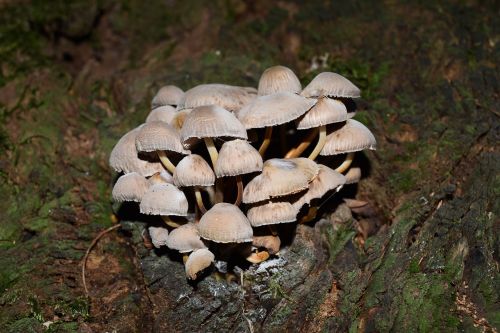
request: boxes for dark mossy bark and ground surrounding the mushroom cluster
[0,0,500,332]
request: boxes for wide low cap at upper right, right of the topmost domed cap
[300,72,361,98]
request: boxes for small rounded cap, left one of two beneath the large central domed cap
[174,154,215,187]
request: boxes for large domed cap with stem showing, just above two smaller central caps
[181,105,247,144]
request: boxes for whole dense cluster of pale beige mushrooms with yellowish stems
[109,66,376,280]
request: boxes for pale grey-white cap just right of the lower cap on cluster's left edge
[139,183,189,216]
